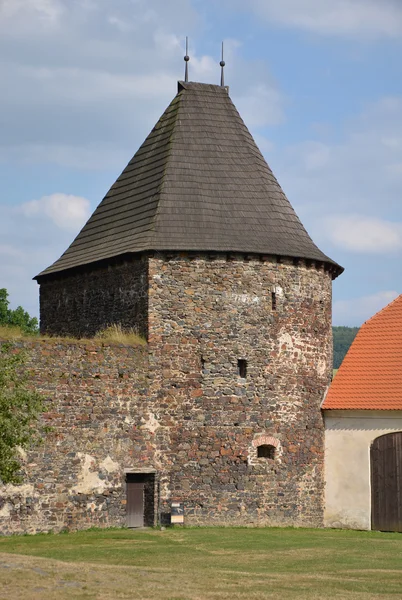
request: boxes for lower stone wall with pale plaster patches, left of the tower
[0,341,155,534]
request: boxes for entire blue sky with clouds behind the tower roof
[0,0,402,325]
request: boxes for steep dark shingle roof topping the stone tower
[37,82,343,278]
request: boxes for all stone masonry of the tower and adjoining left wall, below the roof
[5,253,332,533]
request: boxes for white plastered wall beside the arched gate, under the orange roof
[324,410,402,529]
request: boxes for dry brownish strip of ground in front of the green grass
[0,553,395,600]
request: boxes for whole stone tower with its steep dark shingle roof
[36,82,342,526]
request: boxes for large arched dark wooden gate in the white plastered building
[371,432,402,532]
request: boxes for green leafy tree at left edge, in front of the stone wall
[0,344,48,483]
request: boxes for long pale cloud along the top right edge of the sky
[243,0,402,37]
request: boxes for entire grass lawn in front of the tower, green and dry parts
[0,528,402,600]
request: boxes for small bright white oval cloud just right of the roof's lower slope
[322,215,402,254]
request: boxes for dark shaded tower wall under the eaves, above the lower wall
[40,257,148,338]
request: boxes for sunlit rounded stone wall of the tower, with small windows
[148,254,332,526]
